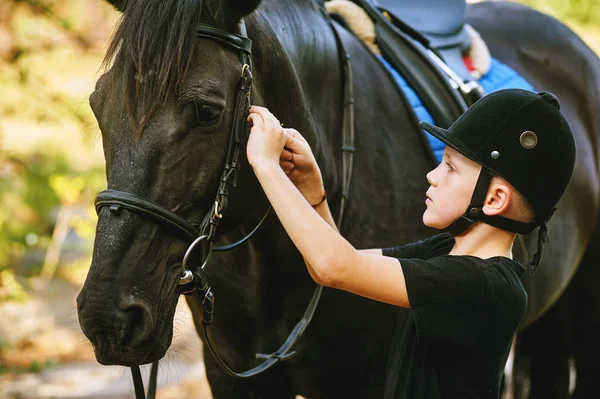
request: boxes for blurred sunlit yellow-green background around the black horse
[0,0,600,398]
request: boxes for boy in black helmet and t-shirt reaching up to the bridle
[247,89,575,399]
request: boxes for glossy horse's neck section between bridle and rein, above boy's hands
[249,0,342,181]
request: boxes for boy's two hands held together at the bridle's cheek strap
[246,106,324,204]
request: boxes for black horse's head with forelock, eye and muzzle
[77,0,260,365]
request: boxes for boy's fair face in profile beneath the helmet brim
[423,147,481,229]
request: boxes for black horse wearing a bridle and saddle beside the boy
[78,0,600,398]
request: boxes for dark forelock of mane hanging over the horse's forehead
[104,0,231,135]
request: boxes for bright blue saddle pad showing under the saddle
[378,56,534,162]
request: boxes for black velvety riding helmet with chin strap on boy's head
[420,89,575,271]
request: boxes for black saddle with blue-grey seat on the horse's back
[353,0,483,127]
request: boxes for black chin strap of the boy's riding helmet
[445,167,555,273]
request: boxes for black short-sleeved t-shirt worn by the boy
[383,234,527,399]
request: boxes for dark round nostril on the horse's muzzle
[117,297,154,346]
